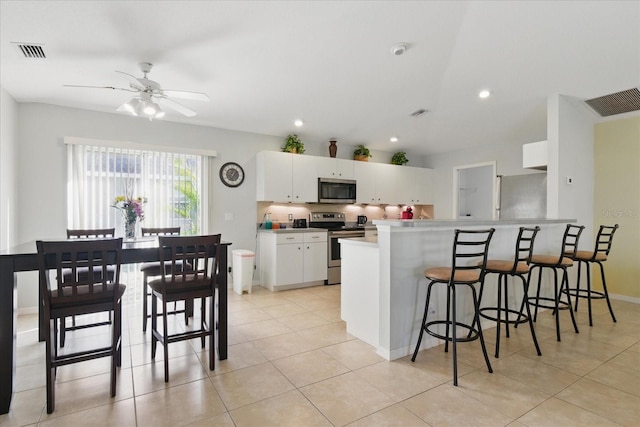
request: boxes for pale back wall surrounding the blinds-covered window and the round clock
[15,104,282,307]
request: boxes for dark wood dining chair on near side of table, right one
[149,234,224,382]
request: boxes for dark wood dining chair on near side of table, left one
[36,239,126,414]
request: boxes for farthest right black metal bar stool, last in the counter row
[564,224,618,326]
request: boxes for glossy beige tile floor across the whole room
[0,286,640,427]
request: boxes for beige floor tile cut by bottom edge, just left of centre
[230,390,331,427]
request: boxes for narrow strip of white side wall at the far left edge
[0,87,18,250]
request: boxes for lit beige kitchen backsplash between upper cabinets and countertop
[256,202,433,225]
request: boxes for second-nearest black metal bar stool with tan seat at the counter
[479,226,542,357]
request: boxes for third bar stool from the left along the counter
[520,224,584,341]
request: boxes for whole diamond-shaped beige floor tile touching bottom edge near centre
[300,373,394,425]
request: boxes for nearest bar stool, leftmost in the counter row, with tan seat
[411,228,495,386]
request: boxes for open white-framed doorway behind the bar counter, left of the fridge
[453,161,497,219]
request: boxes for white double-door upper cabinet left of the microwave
[256,151,318,203]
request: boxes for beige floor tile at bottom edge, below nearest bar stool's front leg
[401,384,512,427]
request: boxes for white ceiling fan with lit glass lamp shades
[64,62,209,120]
